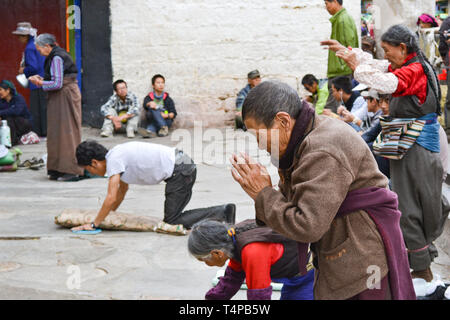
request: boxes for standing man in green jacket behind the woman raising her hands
[325,0,359,112]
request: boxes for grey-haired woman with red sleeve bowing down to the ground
[188,220,314,300]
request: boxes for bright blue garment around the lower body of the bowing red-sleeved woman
[272,269,314,300]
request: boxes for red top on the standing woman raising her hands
[392,62,428,103]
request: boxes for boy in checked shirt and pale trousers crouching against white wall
[100,80,139,138]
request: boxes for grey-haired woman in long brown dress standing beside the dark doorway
[29,34,83,181]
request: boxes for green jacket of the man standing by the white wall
[328,8,359,78]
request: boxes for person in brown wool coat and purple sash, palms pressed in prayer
[231,81,416,300]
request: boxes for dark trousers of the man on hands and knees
[164,150,232,229]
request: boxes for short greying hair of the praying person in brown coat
[242,80,302,128]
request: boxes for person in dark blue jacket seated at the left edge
[0,80,33,146]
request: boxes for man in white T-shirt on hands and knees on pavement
[73,141,236,231]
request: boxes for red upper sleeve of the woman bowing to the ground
[241,242,284,289]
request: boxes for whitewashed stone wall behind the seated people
[110,0,361,127]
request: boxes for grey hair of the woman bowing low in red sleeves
[188,220,235,259]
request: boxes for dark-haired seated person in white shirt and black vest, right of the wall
[331,77,368,127]
